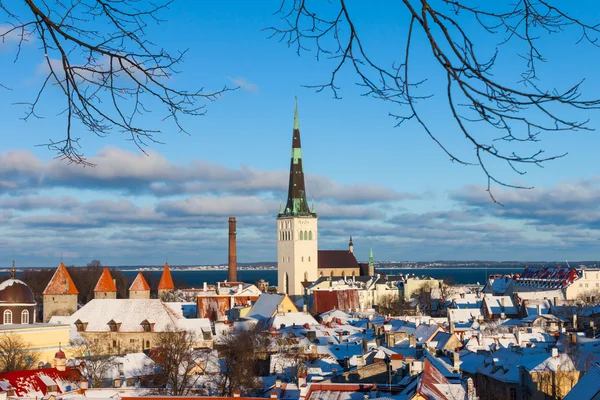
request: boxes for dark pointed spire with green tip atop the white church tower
[279,98,316,217]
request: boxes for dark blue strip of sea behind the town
[118,268,523,288]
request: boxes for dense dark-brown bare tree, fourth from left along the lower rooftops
[215,329,267,397]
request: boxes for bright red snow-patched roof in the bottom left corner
[0,368,81,397]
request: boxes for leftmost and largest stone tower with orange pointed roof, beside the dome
[42,262,79,322]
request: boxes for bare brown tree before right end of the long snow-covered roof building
[153,327,209,396]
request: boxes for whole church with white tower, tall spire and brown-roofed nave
[277,102,366,300]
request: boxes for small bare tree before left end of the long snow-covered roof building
[70,338,116,387]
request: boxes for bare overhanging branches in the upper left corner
[0,0,229,165]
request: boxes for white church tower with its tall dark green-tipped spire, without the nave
[277,101,319,300]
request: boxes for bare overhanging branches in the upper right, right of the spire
[269,0,600,202]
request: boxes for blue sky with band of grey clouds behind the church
[0,0,600,267]
